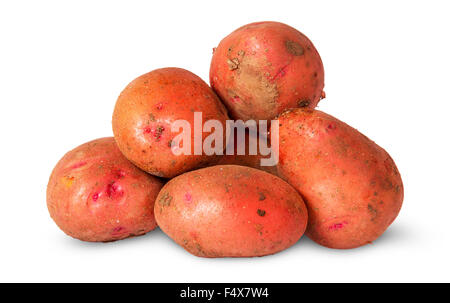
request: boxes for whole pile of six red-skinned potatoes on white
[47,22,403,257]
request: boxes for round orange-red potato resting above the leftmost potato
[112,68,228,178]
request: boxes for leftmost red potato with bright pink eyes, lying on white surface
[47,137,163,242]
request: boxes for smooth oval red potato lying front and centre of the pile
[155,165,308,258]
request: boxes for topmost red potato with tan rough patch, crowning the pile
[210,22,325,120]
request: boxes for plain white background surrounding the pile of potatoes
[0,0,450,282]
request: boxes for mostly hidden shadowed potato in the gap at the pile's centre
[217,132,278,176]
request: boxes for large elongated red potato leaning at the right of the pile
[278,109,403,249]
